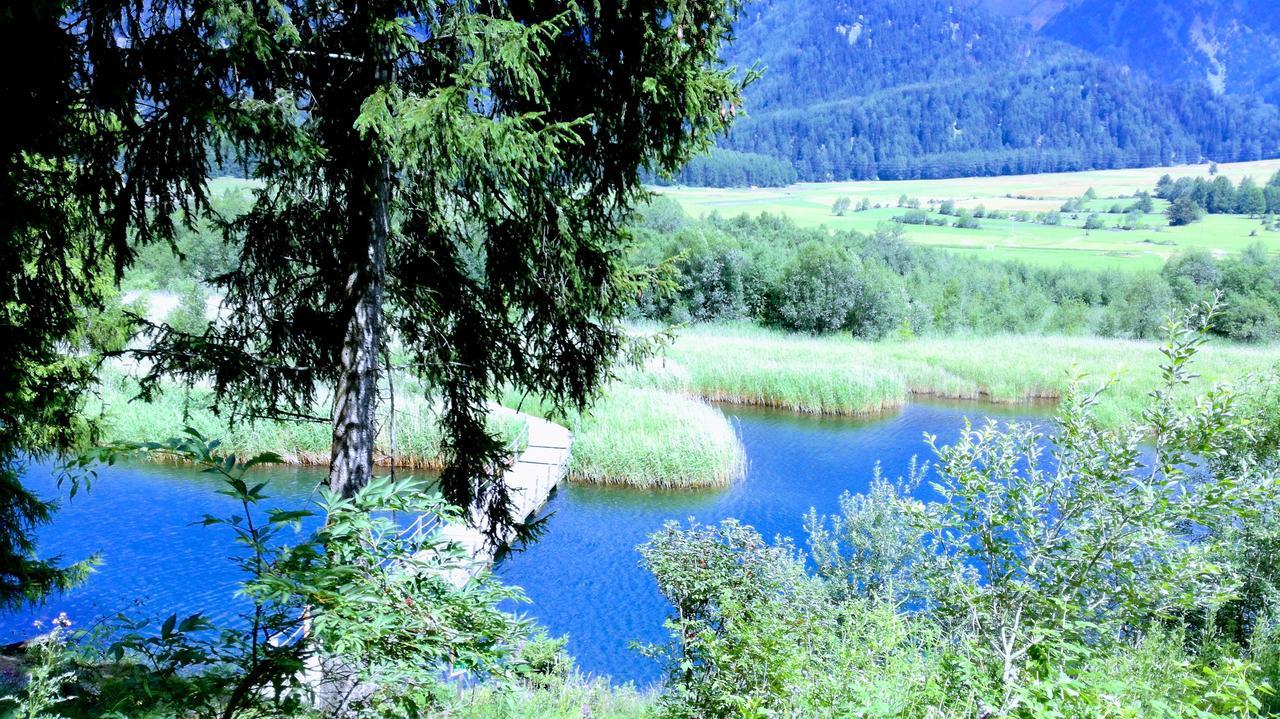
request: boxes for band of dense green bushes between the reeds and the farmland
[634,198,1280,342]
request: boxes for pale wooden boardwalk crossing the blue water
[442,415,573,585]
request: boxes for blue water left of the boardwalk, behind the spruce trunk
[0,461,427,642]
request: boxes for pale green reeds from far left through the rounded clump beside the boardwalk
[97,363,745,489]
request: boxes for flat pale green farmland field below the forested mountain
[659,160,1280,270]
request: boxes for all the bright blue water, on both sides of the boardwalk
[0,403,1044,683]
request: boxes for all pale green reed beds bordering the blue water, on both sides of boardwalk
[102,325,1280,490]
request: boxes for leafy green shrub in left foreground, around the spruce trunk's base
[55,431,526,719]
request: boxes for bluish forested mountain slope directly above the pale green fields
[682,0,1280,186]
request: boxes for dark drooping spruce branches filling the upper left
[0,0,744,598]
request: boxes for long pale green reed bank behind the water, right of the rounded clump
[662,326,1280,423]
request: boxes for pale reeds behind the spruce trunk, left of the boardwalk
[90,370,524,470]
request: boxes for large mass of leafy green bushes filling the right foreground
[640,306,1280,719]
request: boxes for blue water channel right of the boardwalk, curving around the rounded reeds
[498,402,1048,684]
